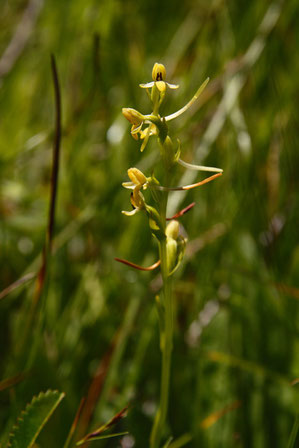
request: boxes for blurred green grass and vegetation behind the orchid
[0,0,299,448]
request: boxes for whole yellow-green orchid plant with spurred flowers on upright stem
[116,63,222,448]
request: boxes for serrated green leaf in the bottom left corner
[8,390,65,448]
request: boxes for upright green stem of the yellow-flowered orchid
[150,189,173,448]
